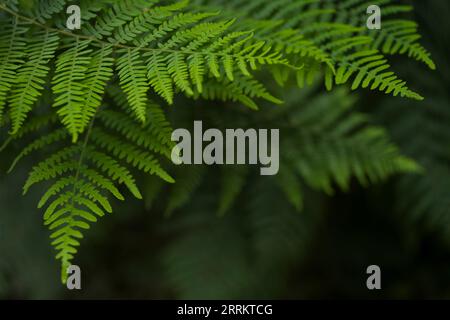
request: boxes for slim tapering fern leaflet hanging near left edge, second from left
[9,31,59,134]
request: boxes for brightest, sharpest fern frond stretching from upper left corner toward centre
[0,0,288,142]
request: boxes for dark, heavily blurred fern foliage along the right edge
[376,1,450,245]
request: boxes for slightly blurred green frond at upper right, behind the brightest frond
[194,0,435,100]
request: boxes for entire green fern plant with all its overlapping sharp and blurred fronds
[0,0,434,281]
